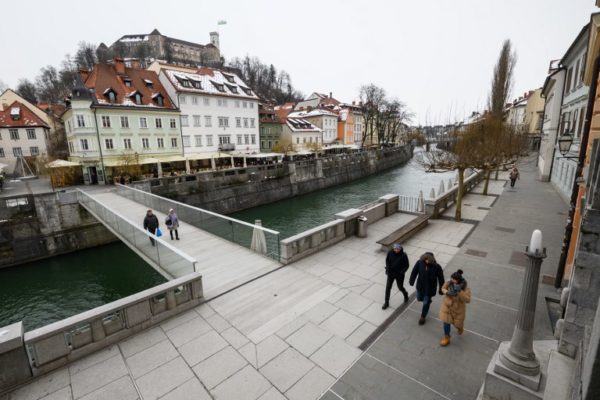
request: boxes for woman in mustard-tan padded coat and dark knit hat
[440,269,471,346]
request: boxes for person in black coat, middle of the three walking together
[409,252,444,325]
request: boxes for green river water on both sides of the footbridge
[0,155,454,330]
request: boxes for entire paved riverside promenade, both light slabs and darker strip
[0,158,567,400]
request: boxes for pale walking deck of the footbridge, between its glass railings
[89,192,281,299]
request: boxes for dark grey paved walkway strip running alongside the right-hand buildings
[321,158,567,400]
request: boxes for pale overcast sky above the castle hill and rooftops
[0,0,598,123]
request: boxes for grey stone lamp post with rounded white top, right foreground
[494,229,546,390]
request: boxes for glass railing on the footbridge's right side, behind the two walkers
[115,184,280,261]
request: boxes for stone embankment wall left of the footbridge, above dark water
[0,193,117,268]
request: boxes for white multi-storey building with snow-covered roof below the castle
[159,67,260,156]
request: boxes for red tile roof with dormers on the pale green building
[82,61,176,109]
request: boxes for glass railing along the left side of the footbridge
[76,189,197,279]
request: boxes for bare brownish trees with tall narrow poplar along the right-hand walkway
[420,40,527,221]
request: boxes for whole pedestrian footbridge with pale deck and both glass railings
[77,185,281,299]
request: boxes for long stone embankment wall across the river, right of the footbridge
[134,145,413,214]
